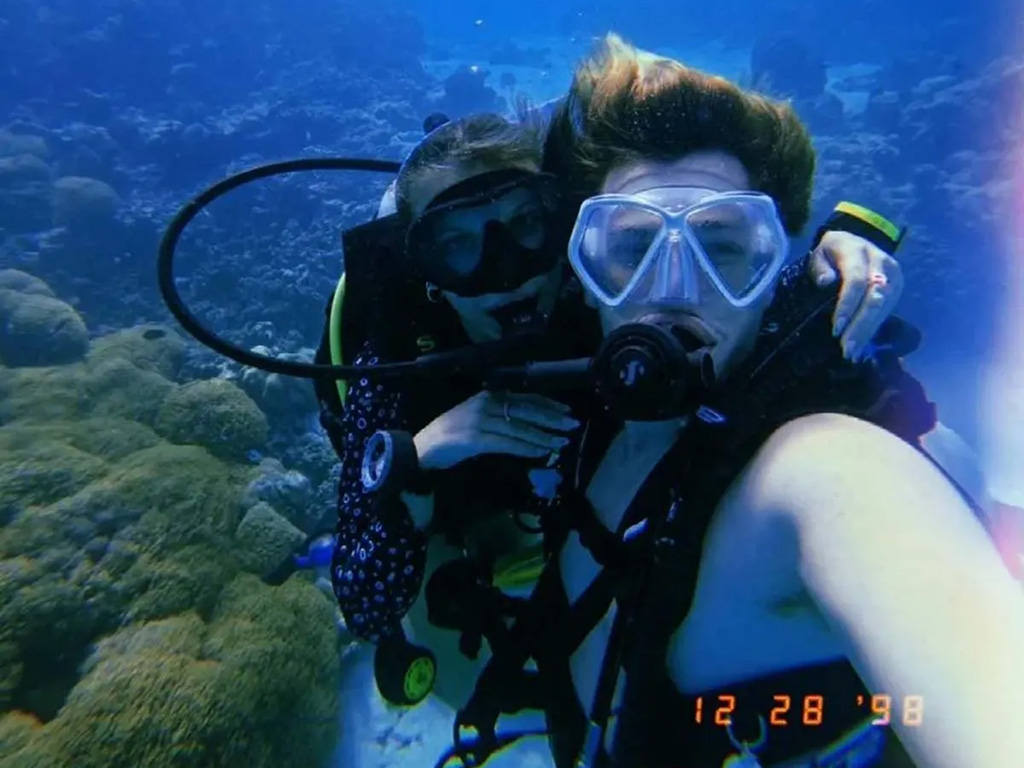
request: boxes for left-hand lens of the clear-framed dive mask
[578,205,663,300]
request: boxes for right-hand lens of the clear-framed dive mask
[686,200,786,299]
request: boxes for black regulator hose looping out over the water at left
[157,158,476,380]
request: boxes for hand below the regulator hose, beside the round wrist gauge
[414,390,580,470]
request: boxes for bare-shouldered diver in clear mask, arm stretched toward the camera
[428,37,1024,768]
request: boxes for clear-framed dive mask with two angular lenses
[568,186,790,308]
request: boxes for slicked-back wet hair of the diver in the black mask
[395,112,544,224]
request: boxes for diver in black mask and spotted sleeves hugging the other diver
[316,107,902,706]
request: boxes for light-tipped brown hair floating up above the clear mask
[545,35,815,234]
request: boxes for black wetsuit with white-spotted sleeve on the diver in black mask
[315,211,600,642]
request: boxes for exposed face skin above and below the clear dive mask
[590,151,772,375]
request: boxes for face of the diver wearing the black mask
[408,163,562,342]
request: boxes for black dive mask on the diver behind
[406,169,558,297]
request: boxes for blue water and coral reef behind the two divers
[0,0,1024,768]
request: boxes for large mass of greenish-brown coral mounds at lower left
[0,325,338,768]
